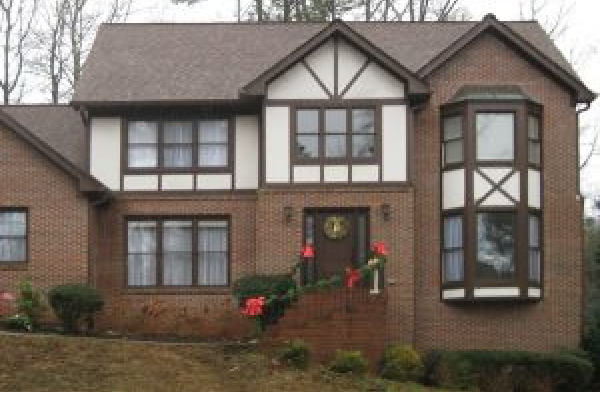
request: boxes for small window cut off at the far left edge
[0,210,27,263]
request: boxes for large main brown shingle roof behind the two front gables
[73,22,573,103]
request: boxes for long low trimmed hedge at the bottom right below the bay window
[425,351,594,391]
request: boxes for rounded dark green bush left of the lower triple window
[48,284,104,333]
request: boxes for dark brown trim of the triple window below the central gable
[288,100,383,165]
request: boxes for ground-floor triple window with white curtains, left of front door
[127,218,229,287]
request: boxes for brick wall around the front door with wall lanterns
[256,187,414,342]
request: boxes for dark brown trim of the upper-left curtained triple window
[121,115,235,175]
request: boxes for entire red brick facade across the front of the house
[0,26,582,350]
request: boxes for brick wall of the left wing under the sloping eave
[0,122,88,315]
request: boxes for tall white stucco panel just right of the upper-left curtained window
[235,116,259,189]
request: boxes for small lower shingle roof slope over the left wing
[0,105,87,172]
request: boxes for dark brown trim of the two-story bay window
[440,100,544,303]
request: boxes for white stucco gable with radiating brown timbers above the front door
[267,37,405,100]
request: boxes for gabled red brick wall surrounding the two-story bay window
[414,35,582,350]
